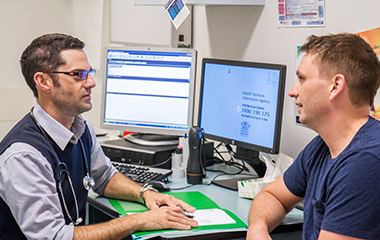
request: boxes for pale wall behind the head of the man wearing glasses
[0,0,104,140]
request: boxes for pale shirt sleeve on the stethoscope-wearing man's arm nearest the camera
[0,143,74,239]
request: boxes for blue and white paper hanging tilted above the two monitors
[165,0,190,29]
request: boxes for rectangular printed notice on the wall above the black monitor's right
[278,0,325,27]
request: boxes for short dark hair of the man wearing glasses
[20,33,85,98]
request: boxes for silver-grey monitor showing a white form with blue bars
[101,46,197,145]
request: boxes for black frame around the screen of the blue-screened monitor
[198,58,286,154]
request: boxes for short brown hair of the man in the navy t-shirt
[300,33,380,106]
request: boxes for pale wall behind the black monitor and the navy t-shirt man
[193,0,380,158]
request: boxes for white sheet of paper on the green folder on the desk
[192,208,236,226]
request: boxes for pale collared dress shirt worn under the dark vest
[0,103,117,240]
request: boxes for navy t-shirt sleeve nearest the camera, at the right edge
[321,153,380,239]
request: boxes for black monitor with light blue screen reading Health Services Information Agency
[198,58,286,177]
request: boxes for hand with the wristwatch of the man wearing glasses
[143,191,195,212]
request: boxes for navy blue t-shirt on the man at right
[284,117,380,239]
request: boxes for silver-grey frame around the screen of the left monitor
[100,46,197,136]
